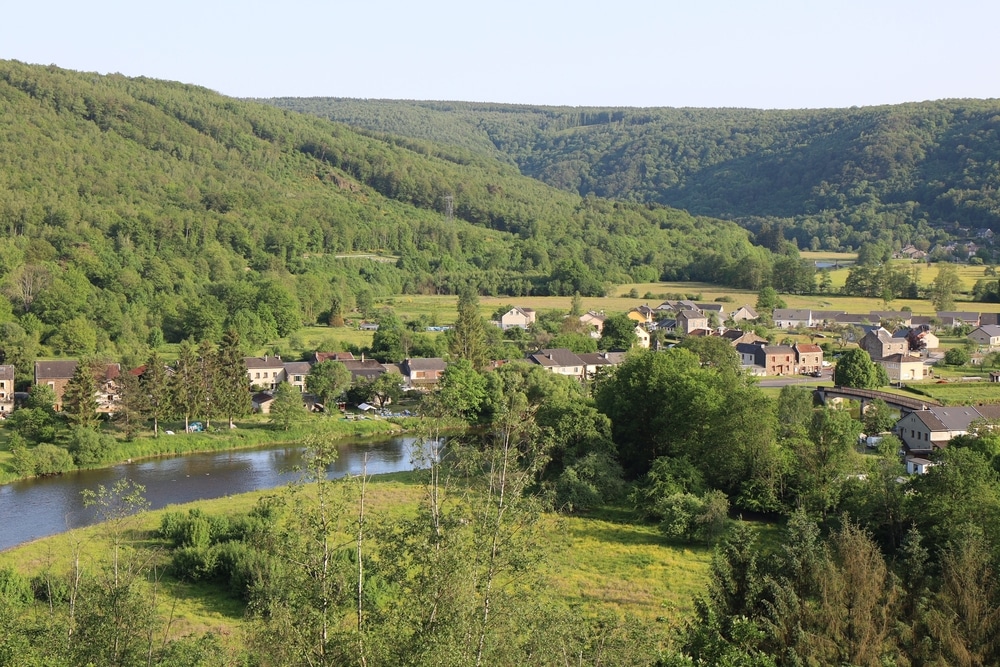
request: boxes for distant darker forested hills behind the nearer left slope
[268,98,1000,250]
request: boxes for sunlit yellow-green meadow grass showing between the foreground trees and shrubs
[0,472,720,637]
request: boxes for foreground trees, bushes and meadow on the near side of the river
[0,352,1000,665]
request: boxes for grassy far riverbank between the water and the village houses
[0,416,430,485]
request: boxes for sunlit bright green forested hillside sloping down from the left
[0,61,761,373]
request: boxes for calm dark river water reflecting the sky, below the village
[0,437,426,551]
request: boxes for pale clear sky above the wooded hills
[0,0,1000,109]
